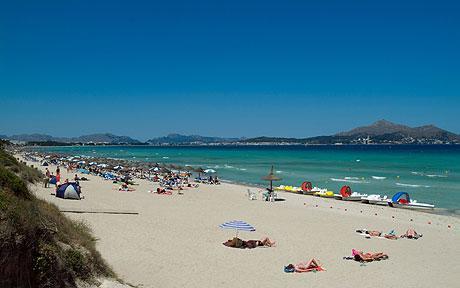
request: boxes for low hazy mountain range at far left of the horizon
[6,133,142,144]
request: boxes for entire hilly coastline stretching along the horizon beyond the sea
[0,120,460,147]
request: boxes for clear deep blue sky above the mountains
[0,0,460,139]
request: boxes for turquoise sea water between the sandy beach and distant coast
[33,146,460,213]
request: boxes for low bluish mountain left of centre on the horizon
[147,134,240,145]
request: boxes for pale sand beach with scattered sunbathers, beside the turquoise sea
[20,158,460,288]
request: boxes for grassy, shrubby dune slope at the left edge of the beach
[0,148,115,288]
